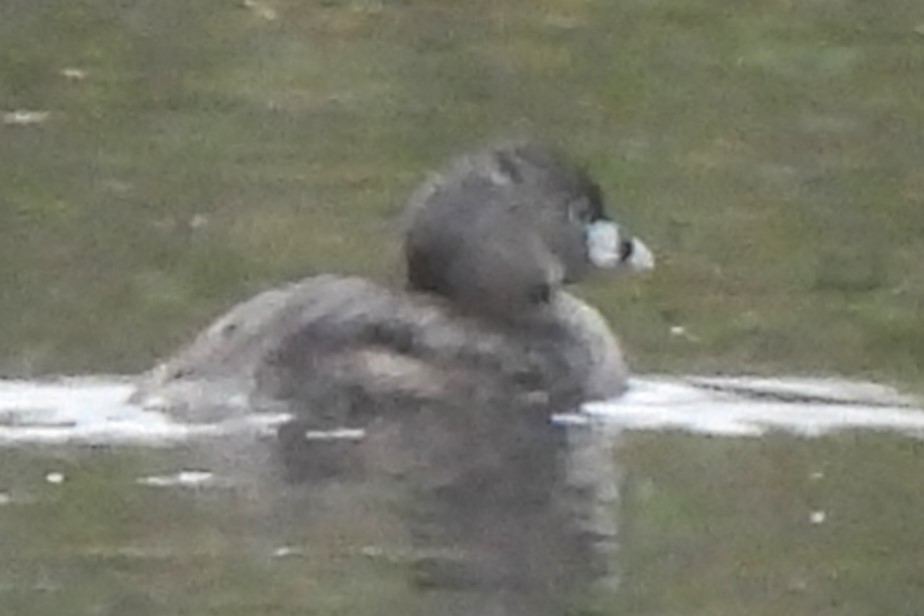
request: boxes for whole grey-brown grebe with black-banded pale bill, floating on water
[135,143,652,438]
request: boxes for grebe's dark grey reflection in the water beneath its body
[281,390,618,616]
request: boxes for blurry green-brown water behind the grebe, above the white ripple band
[0,0,924,386]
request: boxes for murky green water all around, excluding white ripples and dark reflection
[0,0,924,616]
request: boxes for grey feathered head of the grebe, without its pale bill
[405,143,605,314]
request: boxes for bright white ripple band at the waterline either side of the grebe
[0,376,924,446]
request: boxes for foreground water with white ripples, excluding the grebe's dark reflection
[0,377,924,615]
